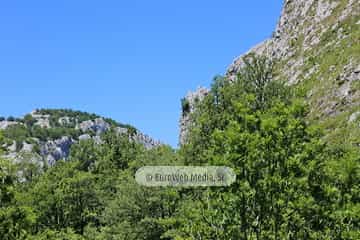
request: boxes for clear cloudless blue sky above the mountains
[0,0,282,146]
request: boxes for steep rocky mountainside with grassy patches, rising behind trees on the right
[179,0,360,145]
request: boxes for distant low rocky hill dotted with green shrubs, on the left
[0,109,161,169]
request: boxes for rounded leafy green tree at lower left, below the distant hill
[24,162,100,233]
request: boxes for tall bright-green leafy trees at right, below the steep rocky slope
[173,55,360,239]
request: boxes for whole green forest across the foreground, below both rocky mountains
[0,56,360,240]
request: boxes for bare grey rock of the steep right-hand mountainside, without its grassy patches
[179,0,360,144]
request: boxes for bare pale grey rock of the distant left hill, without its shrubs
[0,110,161,166]
